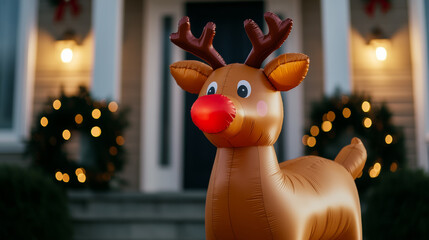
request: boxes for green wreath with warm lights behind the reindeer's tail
[302,94,405,193]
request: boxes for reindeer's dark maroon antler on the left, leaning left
[170,17,226,69]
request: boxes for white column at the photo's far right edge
[408,0,429,171]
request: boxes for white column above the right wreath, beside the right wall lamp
[321,0,351,96]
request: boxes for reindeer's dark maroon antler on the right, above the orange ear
[244,12,292,68]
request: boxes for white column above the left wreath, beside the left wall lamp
[91,0,123,101]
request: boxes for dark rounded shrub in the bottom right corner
[363,170,429,240]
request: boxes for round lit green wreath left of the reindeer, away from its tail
[27,87,127,189]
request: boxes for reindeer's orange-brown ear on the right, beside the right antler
[264,53,310,91]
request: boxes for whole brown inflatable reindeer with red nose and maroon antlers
[170,13,366,240]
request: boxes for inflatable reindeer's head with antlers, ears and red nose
[170,13,309,147]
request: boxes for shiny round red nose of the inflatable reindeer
[191,94,235,133]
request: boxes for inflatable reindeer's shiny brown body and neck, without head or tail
[206,146,362,240]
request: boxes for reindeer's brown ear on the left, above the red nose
[170,60,213,94]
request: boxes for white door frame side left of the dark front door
[140,0,184,192]
